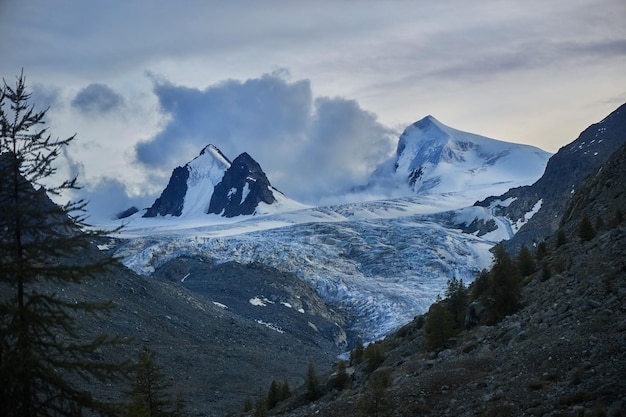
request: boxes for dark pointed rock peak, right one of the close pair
[208,152,276,217]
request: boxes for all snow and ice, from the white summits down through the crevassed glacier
[113,116,550,341]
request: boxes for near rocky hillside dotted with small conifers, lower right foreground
[272,145,626,417]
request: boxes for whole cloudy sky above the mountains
[0,0,626,218]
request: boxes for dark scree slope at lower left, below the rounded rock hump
[0,244,341,416]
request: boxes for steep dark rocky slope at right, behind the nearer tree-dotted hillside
[476,104,626,253]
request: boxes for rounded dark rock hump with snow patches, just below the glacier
[149,257,348,352]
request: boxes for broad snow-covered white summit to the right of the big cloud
[370,116,550,199]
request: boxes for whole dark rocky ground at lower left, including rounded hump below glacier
[0,242,345,416]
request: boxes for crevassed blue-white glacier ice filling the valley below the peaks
[116,195,512,341]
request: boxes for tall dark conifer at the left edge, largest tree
[0,73,127,417]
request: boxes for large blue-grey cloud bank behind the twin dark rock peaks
[136,71,395,202]
